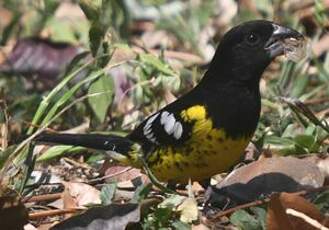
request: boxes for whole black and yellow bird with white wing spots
[37,20,303,183]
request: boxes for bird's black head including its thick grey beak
[208,20,303,84]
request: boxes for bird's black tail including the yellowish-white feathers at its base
[35,133,141,165]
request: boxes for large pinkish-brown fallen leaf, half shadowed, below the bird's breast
[206,157,324,208]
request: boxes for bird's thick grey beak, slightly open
[265,23,304,58]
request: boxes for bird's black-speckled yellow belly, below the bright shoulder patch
[151,130,249,182]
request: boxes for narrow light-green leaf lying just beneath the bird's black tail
[37,145,86,161]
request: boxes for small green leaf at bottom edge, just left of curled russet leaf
[230,209,262,230]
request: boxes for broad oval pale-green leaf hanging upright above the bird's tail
[88,74,114,122]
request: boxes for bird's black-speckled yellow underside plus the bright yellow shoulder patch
[147,105,251,182]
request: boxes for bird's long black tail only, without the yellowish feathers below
[35,133,134,154]
